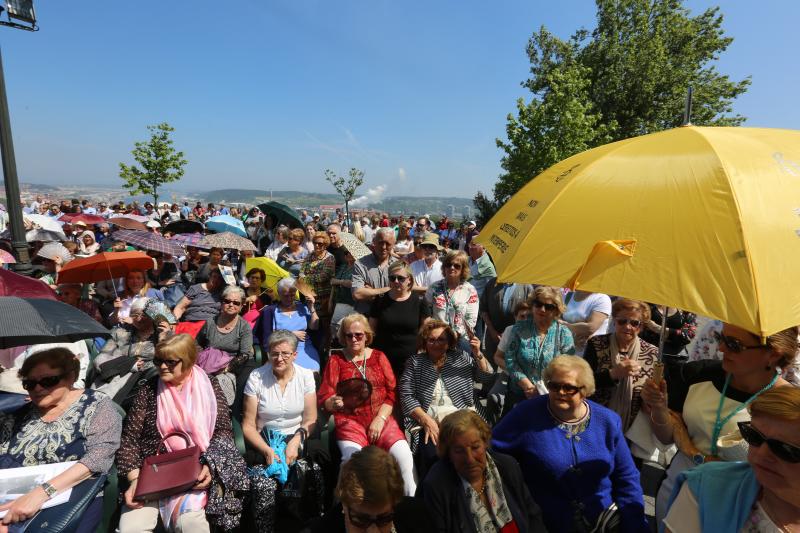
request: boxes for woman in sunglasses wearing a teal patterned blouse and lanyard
[503,287,575,413]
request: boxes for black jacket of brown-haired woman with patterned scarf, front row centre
[417,451,547,533]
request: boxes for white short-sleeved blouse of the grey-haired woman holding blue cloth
[244,363,316,435]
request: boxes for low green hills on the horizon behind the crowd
[200,189,475,217]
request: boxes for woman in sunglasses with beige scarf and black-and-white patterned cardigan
[583,298,658,432]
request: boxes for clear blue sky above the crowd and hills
[0,0,800,197]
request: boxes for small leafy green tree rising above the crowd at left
[119,122,187,208]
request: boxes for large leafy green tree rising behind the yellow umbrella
[475,0,750,222]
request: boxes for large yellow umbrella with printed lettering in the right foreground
[477,126,800,336]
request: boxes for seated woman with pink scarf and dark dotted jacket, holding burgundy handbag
[117,335,233,533]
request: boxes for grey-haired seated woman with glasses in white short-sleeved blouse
[242,329,317,465]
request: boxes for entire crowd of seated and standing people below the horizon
[0,197,800,533]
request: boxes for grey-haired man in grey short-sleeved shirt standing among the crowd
[353,228,395,314]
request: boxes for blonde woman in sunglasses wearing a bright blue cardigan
[492,355,648,532]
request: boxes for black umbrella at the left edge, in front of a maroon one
[0,296,111,348]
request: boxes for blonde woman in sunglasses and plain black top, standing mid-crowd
[369,261,428,377]
